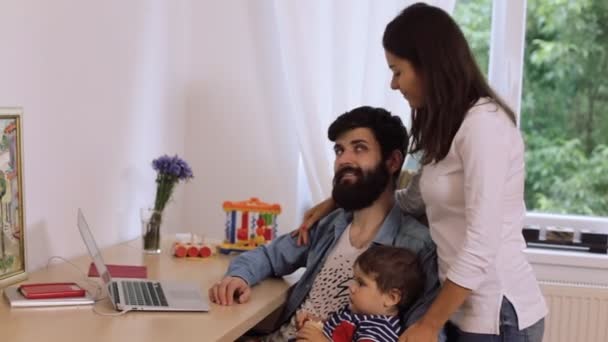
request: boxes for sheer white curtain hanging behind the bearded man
[256,0,455,203]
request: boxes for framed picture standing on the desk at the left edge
[0,107,27,288]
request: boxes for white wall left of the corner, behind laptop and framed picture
[0,0,187,269]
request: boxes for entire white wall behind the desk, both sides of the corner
[0,0,306,270]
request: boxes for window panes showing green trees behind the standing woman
[454,0,608,231]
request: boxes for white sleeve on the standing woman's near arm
[446,111,512,291]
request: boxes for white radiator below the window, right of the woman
[539,275,608,342]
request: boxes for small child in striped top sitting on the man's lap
[297,245,424,341]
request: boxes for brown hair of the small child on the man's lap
[355,245,425,312]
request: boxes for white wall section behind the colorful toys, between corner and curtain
[184,0,302,238]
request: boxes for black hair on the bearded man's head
[327,106,409,181]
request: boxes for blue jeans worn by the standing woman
[446,297,545,342]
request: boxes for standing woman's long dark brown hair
[382,3,516,165]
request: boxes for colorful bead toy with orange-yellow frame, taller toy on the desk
[218,197,281,254]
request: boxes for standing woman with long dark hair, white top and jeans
[300,4,547,342]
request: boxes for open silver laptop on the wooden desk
[78,209,209,312]
